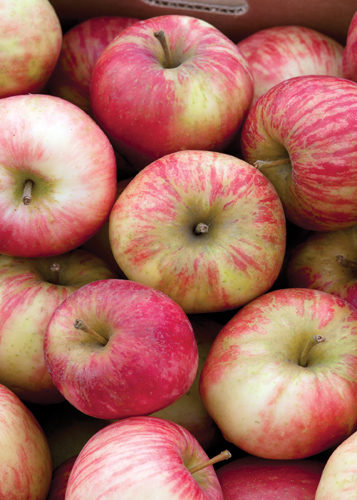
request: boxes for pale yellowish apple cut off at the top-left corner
[0,0,62,97]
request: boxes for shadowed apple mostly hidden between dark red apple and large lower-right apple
[152,316,222,450]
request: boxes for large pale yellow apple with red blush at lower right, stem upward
[200,288,357,460]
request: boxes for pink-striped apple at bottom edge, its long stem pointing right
[66,417,223,500]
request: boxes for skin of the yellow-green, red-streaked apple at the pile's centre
[109,151,286,313]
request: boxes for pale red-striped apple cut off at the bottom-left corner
[0,384,52,500]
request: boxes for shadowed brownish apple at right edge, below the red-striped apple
[286,226,357,307]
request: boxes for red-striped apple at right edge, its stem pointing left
[241,75,357,231]
